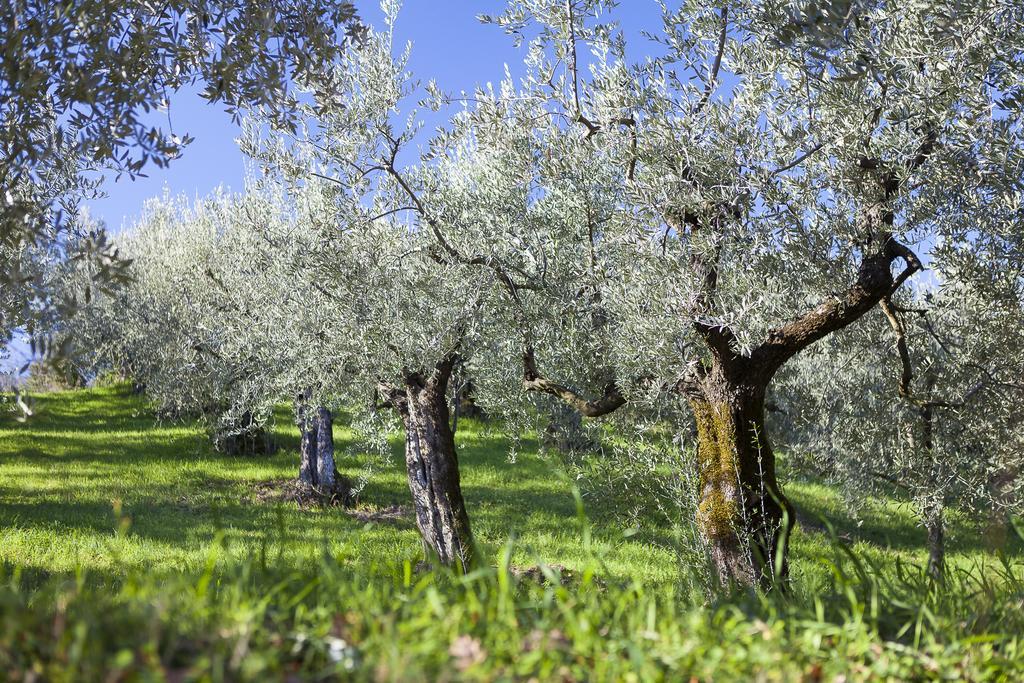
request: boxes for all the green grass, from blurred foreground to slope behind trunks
[0,388,1024,680]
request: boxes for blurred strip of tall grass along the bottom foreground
[0,558,1024,681]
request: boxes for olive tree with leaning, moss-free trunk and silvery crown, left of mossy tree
[245,163,493,570]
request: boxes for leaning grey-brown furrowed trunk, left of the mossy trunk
[383,359,475,571]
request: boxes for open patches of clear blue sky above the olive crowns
[88,0,659,230]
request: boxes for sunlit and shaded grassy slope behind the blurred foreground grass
[0,388,1021,583]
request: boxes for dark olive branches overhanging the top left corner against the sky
[0,0,359,360]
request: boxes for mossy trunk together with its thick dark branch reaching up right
[677,233,922,589]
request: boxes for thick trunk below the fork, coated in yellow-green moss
[688,366,795,589]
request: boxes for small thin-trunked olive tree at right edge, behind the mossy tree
[777,284,1024,578]
